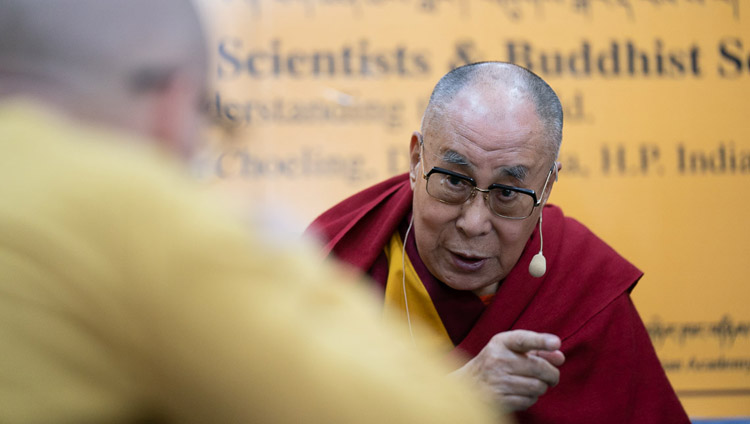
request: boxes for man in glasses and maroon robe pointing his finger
[310,62,689,424]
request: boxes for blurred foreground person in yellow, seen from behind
[0,0,506,423]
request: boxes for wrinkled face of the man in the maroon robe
[411,90,557,294]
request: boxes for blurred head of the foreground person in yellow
[0,0,207,156]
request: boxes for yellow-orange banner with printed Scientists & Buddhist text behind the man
[195,0,750,417]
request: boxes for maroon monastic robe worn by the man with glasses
[310,174,689,424]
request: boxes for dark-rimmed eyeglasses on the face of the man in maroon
[422,147,555,219]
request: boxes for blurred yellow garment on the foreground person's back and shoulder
[0,101,506,424]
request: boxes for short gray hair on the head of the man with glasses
[421,62,563,159]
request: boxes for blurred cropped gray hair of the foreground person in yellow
[0,0,205,94]
